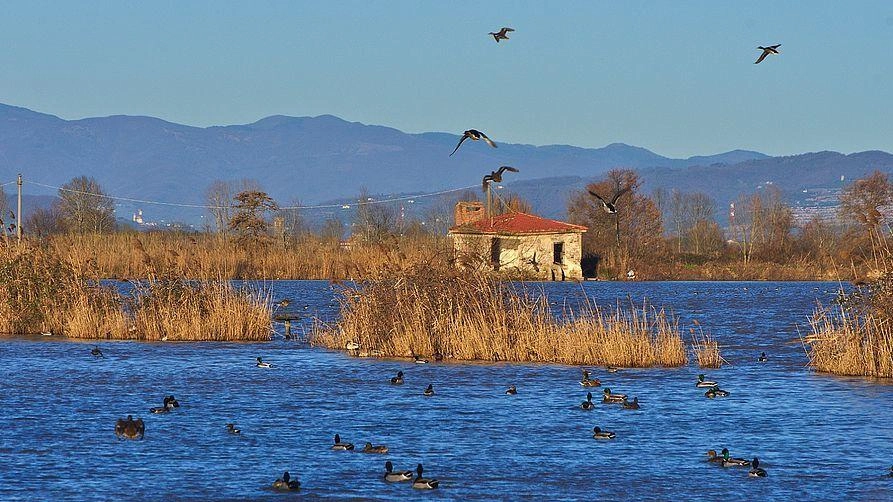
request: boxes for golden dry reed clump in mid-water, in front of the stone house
[310,267,687,367]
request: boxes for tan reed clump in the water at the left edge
[0,242,272,341]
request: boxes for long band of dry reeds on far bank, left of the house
[48,232,452,280]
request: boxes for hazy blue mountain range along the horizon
[0,104,893,223]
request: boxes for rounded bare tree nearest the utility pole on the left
[57,176,115,233]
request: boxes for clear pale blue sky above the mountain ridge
[0,0,893,157]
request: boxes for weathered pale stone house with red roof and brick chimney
[449,202,586,281]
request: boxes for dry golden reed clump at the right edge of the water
[804,308,893,378]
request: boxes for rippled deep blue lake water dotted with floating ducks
[0,281,893,500]
